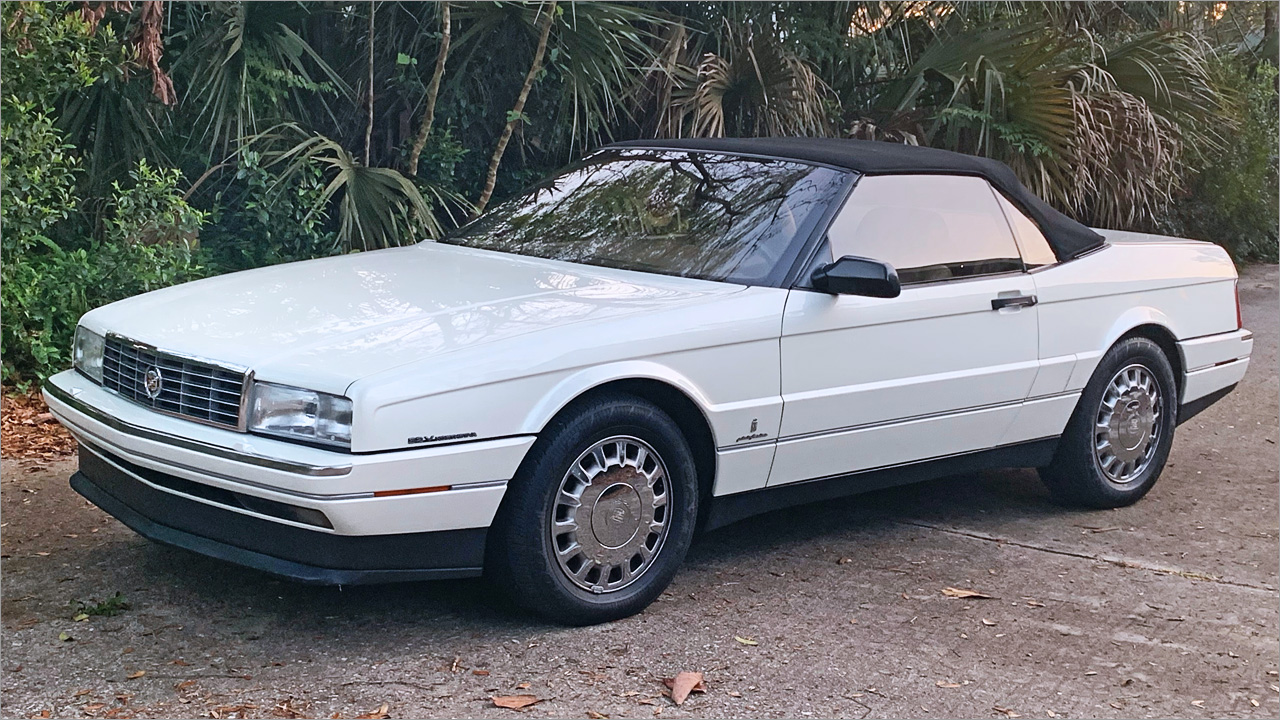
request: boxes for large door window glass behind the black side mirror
[828,176,1023,284]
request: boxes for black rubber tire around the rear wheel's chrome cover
[1039,337,1178,509]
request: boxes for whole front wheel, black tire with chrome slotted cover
[485,395,698,625]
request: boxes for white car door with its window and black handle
[769,176,1038,486]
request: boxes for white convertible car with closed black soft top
[45,138,1252,624]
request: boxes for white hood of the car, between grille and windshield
[82,242,742,393]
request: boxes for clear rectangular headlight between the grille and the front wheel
[248,383,351,448]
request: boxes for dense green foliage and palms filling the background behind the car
[0,0,1280,383]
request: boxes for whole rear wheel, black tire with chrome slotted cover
[1039,337,1178,507]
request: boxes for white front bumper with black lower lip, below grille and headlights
[45,372,534,584]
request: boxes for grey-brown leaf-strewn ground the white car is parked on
[0,266,1280,717]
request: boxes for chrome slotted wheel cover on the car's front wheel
[549,436,671,594]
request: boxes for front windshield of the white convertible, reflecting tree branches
[442,149,847,284]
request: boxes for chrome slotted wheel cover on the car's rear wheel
[1093,364,1161,486]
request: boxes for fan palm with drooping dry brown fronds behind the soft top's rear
[851,16,1221,227]
